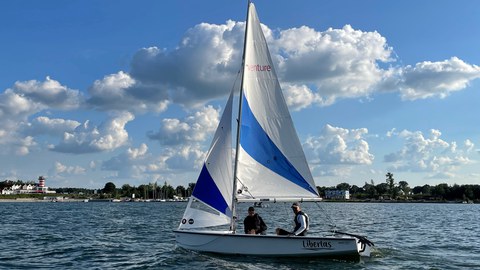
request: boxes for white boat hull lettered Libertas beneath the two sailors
[174,230,370,259]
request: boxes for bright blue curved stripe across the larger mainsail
[240,96,317,194]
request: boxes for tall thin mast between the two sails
[230,0,251,233]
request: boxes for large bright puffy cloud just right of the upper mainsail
[271,25,393,105]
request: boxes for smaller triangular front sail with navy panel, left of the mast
[179,90,234,229]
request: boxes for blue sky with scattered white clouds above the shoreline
[0,0,480,188]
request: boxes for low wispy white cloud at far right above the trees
[384,129,473,175]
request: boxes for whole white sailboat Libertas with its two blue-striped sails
[174,1,373,258]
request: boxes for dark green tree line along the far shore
[0,172,480,202]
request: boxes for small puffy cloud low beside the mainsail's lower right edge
[303,125,374,165]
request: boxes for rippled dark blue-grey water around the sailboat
[0,202,480,270]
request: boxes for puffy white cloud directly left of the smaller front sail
[102,106,220,179]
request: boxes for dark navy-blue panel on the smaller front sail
[192,164,230,215]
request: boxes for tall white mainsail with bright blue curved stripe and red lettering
[237,4,318,198]
